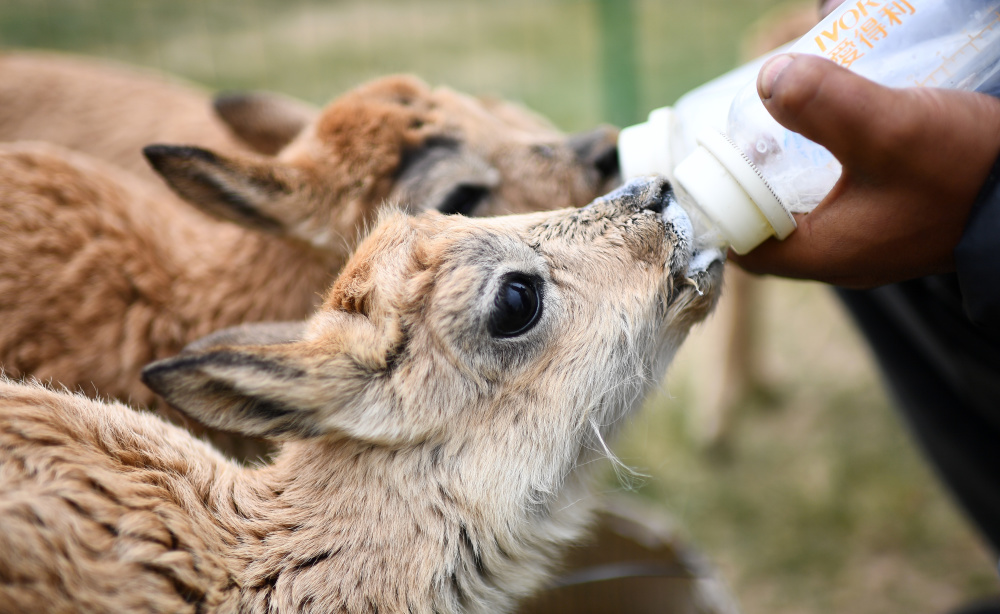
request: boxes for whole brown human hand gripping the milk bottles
[730,54,1000,288]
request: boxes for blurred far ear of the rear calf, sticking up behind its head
[212,92,319,156]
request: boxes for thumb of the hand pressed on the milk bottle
[757,54,901,171]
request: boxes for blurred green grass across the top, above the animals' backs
[0,0,808,130]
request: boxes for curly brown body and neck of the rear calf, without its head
[0,143,335,414]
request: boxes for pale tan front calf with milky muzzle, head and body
[0,181,722,614]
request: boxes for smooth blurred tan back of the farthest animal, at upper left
[0,52,246,198]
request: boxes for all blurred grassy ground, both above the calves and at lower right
[0,0,1000,614]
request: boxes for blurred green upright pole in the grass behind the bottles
[594,0,643,126]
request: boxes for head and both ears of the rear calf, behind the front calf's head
[145,76,618,256]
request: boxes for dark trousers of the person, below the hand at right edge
[837,276,1000,552]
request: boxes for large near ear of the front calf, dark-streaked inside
[142,311,414,443]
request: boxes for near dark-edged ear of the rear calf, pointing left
[142,145,305,234]
